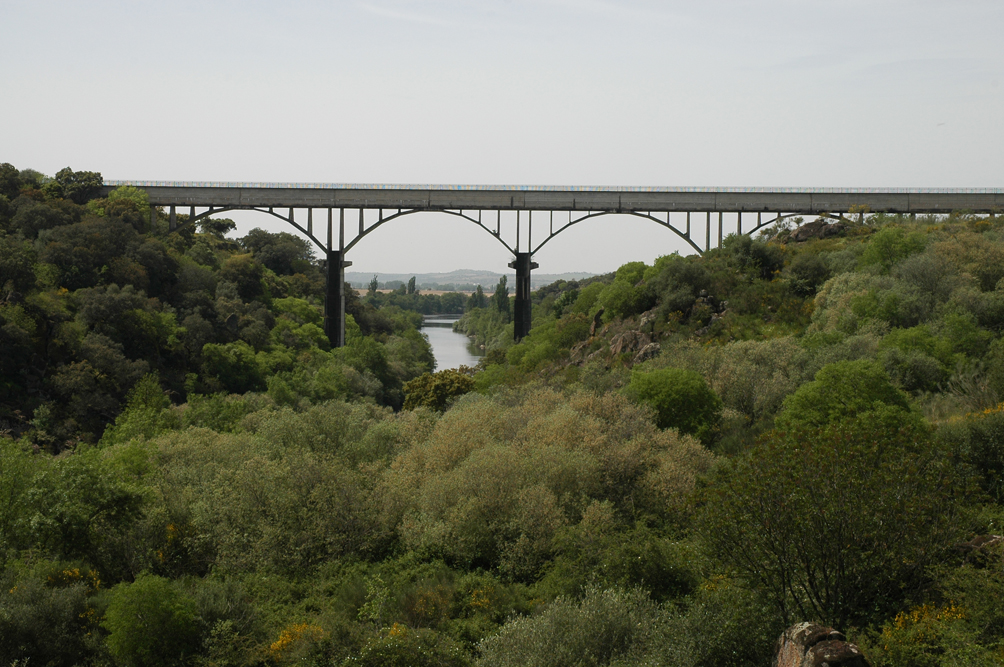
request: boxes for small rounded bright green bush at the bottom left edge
[101,575,200,667]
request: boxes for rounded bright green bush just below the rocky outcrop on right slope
[624,368,722,441]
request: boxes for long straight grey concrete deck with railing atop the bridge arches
[104,181,1004,215]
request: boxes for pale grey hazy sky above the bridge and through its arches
[0,0,1004,272]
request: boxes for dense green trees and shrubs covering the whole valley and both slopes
[0,165,1004,667]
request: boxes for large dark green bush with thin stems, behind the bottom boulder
[701,409,964,628]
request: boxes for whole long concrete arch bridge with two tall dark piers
[103,181,1004,347]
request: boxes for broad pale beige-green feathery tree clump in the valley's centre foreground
[381,390,711,581]
